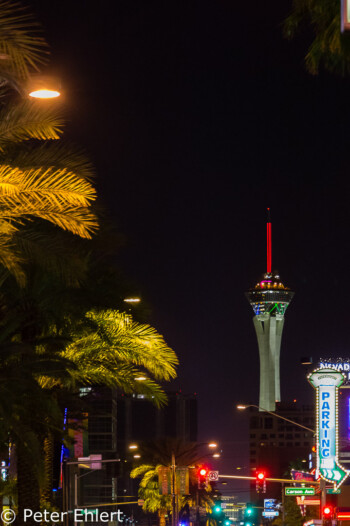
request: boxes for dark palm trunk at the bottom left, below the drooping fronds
[16,443,40,526]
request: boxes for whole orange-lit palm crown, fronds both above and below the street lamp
[0,0,98,284]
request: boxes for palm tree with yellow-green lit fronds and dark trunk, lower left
[0,267,178,520]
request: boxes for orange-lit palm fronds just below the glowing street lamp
[0,97,98,284]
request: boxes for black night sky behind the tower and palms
[30,0,350,496]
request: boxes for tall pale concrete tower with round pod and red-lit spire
[246,212,294,411]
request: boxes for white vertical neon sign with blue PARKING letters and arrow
[308,369,349,488]
